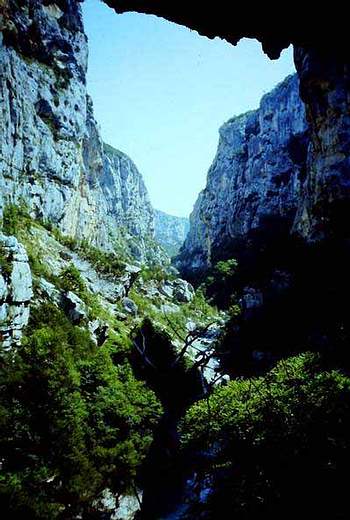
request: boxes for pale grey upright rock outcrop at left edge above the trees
[0,234,33,350]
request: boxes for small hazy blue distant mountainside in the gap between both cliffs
[154,209,190,256]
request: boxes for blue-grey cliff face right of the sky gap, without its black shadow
[178,76,308,274]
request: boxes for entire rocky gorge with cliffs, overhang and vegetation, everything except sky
[0,0,350,520]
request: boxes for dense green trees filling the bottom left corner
[0,304,161,519]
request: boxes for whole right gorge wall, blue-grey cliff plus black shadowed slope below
[178,72,350,375]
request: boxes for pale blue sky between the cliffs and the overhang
[83,0,294,216]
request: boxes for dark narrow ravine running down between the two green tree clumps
[130,321,224,520]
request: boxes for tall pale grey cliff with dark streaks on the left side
[0,0,158,260]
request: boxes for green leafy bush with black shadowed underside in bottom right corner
[182,353,350,519]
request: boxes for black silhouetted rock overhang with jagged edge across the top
[104,0,348,59]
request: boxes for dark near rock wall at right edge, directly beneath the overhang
[294,47,350,242]
